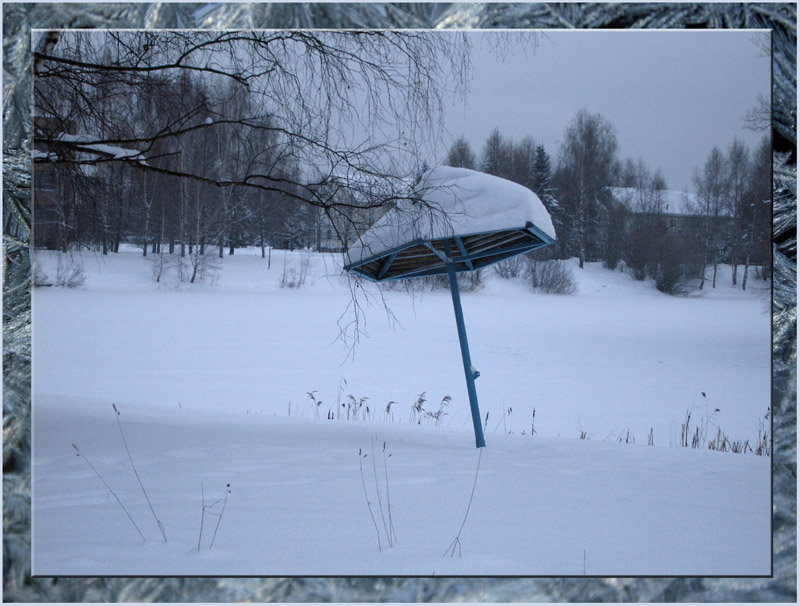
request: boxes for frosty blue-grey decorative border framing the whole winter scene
[3,3,797,602]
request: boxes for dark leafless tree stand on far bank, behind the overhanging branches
[36,74,300,256]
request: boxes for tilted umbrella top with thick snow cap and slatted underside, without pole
[345,166,556,281]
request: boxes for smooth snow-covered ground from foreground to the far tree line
[33,251,771,576]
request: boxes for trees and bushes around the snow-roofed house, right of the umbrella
[444,110,771,292]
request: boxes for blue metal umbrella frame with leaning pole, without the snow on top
[345,222,555,448]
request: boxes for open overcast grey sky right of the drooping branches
[443,30,770,190]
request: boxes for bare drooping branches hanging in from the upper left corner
[34,31,468,221]
